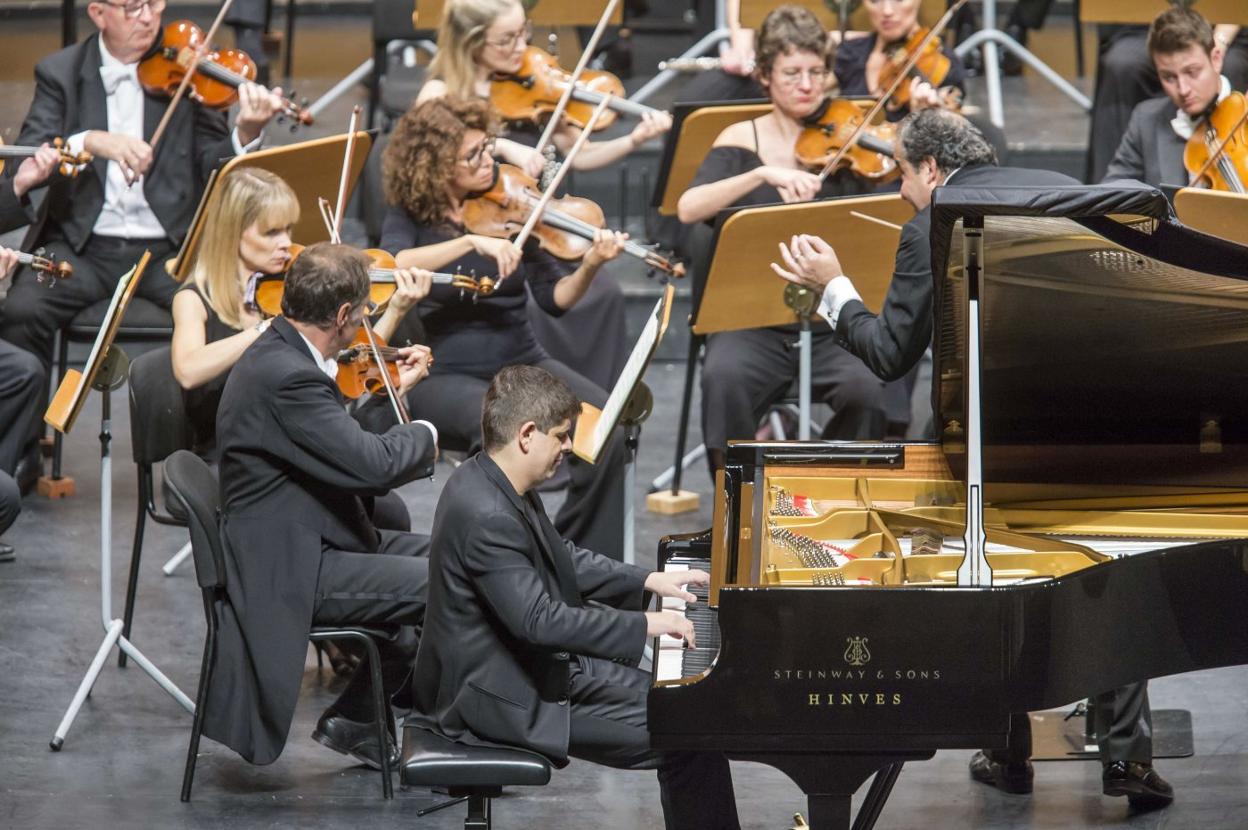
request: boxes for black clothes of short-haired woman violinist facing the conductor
[690,132,885,467]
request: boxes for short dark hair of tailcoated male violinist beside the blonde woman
[282,242,369,328]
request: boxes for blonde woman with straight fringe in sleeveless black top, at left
[172,167,431,454]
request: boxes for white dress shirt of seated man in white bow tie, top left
[67,37,263,240]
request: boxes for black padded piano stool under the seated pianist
[399,724,550,830]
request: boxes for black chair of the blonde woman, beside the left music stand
[117,346,191,668]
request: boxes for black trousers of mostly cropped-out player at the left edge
[0,339,47,533]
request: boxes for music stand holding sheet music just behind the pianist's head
[572,282,676,564]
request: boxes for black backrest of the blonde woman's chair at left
[130,346,191,466]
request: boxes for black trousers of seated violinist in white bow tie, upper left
[0,236,178,369]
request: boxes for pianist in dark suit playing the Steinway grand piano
[407,366,740,830]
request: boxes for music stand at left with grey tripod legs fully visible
[44,252,195,751]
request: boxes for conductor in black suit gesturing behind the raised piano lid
[771,109,1173,809]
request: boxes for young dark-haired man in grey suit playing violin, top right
[1104,9,1232,187]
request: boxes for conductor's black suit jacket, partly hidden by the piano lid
[836,165,1080,381]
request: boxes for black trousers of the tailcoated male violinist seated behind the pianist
[312,530,429,721]
